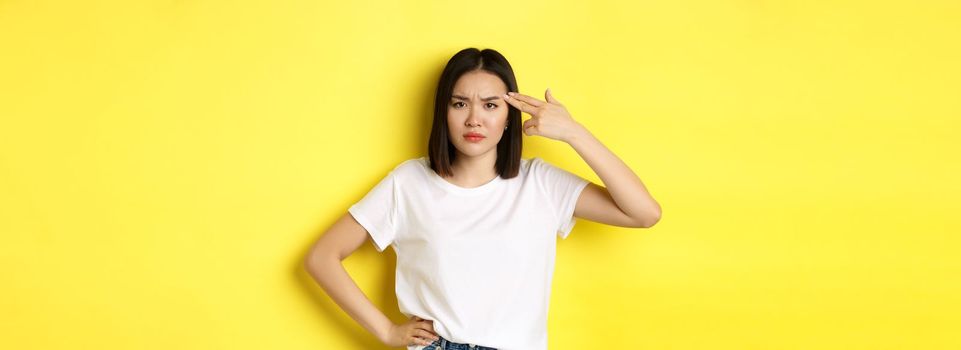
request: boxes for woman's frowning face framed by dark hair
[447,70,510,157]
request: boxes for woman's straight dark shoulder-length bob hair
[427,48,522,179]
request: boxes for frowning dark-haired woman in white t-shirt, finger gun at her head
[305,48,661,350]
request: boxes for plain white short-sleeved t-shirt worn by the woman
[348,157,589,350]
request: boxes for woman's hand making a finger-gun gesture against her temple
[504,89,583,143]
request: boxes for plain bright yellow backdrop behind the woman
[0,0,961,349]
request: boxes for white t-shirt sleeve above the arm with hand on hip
[347,171,398,252]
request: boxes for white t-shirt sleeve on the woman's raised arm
[531,157,590,239]
